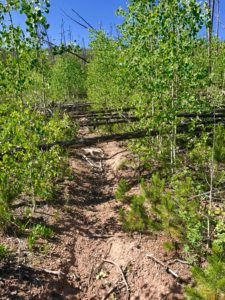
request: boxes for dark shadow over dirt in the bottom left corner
[0,258,79,300]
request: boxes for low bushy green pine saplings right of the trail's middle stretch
[120,173,206,252]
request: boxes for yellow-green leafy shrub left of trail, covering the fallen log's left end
[0,104,76,228]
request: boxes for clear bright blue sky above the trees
[11,0,225,47]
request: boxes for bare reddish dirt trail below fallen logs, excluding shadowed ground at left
[59,142,187,300]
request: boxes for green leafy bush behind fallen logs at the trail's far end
[87,30,129,109]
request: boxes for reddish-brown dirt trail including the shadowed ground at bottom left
[0,135,188,300]
